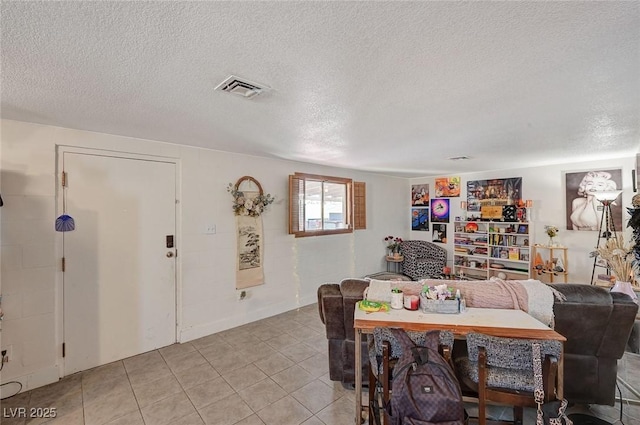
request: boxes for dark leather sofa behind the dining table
[318,279,638,405]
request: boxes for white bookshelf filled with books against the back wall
[453,221,532,280]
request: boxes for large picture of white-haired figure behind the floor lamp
[565,169,623,231]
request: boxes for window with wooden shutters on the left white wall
[289,173,366,237]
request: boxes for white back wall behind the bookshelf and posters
[412,157,635,283]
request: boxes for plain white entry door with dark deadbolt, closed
[61,151,176,375]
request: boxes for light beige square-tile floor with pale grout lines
[0,304,640,425]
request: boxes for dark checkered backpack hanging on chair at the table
[387,329,465,425]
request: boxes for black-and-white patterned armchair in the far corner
[400,240,447,280]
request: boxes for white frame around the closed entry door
[51,144,183,378]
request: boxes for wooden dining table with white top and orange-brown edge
[354,306,566,425]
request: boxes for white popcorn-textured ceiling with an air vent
[1,1,640,176]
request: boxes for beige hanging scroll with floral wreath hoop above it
[227,176,274,289]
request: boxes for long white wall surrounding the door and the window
[0,120,409,390]
